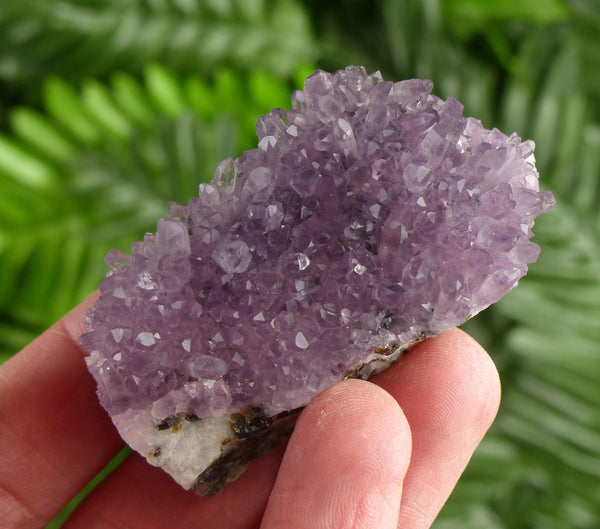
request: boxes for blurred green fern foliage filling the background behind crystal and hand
[0,0,600,529]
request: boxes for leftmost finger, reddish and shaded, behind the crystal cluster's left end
[0,297,122,529]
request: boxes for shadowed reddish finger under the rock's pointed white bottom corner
[62,448,283,529]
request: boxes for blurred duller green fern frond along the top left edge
[0,0,317,98]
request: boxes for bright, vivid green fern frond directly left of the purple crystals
[0,63,300,351]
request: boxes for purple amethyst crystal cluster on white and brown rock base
[82,67,553,494]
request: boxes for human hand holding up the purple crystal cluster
[0,295,500,529]
